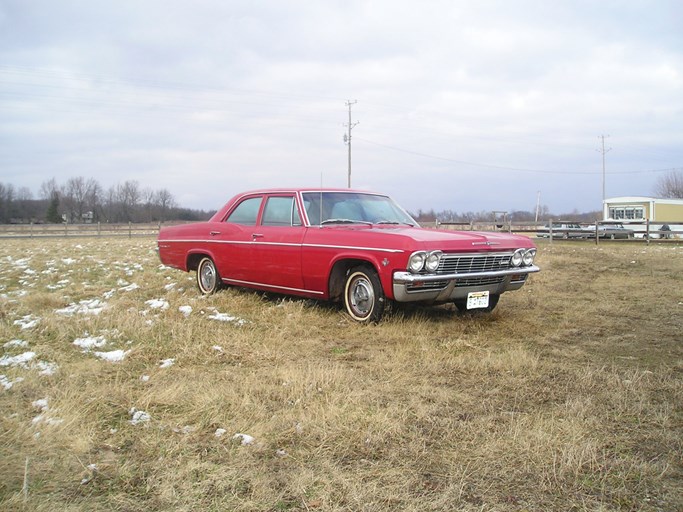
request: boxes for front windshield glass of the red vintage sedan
[302,192,417,226]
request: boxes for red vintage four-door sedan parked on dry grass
[157,189,539,322]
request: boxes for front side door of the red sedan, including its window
[252,194,306,292]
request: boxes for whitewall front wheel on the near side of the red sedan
[344,266,386,322]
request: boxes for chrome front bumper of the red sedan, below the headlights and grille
[393,265,541,302]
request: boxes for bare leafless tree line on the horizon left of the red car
[0,177,211,224]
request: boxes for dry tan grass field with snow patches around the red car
[0,238,683,511]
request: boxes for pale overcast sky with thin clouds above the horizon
[0,0,683,213]
